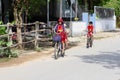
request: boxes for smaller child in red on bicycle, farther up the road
[87,21,94,48]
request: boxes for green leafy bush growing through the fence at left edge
[0,21,18,58]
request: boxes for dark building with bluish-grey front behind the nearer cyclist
[49,0,82,21]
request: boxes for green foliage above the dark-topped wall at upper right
[78,0,120,17]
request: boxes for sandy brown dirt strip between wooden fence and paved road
[0,48,53,67]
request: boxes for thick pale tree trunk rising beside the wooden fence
[13,0,27,49]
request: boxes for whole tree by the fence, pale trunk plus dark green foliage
[13,0,47,48]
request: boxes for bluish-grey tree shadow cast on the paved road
[75,51,120,69]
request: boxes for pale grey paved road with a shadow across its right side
[0,37,120,80]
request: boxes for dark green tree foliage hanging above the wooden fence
[14,0,47,19]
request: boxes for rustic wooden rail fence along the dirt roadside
[0,22,52,49]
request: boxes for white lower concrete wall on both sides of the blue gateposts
[71,19,116,37]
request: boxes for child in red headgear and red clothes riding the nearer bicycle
[54,18,67,53]
